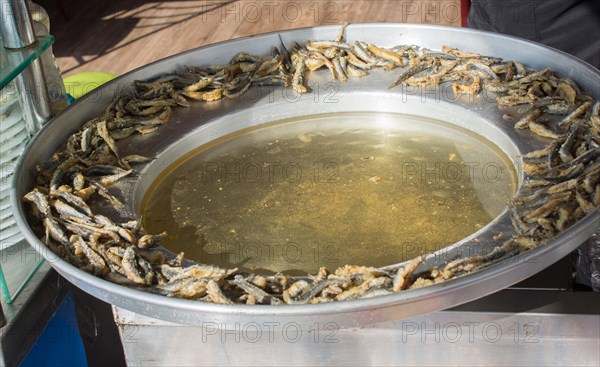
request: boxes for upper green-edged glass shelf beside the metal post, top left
[0,35,54,89]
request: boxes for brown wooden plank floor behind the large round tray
[37,0,460,76]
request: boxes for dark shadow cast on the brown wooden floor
[36,0,236,73]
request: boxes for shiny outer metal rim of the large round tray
[11,23,600,326]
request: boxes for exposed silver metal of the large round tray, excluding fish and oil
[12,24,600,328]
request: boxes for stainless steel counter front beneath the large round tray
[113,292,600,366]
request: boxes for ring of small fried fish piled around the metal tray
[25,23,600,305]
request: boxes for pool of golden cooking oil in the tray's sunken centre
[142,113,516,274]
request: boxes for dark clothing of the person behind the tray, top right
[467,0,600,69]
